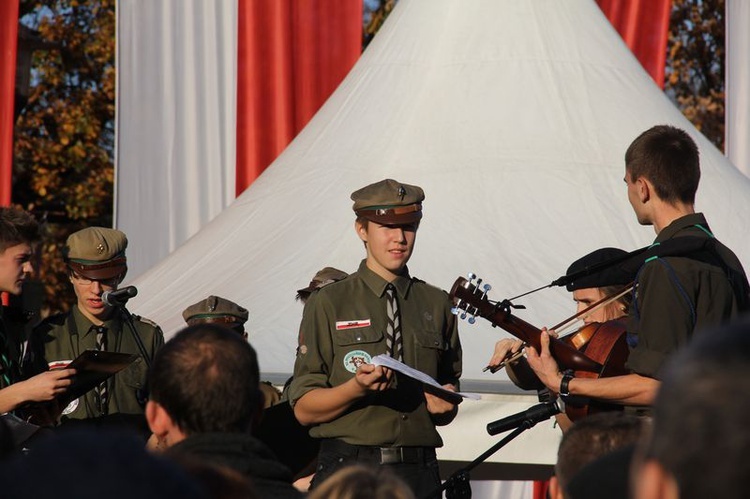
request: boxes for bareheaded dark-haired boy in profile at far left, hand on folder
[0,208,75,414]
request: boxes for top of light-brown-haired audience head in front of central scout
[308,464,414,499]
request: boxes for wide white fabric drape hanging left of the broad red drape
[115,0,237,278]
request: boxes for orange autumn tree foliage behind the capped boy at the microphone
[13,0,115,311]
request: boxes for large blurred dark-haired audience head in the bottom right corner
[633,317,750,499]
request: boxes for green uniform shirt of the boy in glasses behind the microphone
[29,305,164,419]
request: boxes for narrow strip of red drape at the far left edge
[0,0,18,206]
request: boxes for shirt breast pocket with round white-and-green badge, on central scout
[331,327,385,384]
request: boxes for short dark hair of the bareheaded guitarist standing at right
[625,125,701,204]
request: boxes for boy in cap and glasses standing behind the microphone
[29,227,164,423]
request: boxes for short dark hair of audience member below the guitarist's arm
[555,411,643,490]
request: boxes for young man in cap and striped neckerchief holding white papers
[290,179,461,497]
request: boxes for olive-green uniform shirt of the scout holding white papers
[289,261,461,447]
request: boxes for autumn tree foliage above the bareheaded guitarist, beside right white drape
[664,0,725,151]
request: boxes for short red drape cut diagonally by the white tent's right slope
[596,0,672,88]
